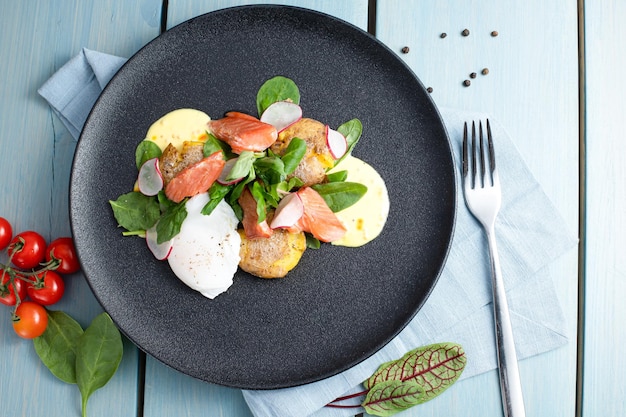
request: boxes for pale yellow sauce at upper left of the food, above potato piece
[145,109,211,151]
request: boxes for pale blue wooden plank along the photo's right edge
[582,0,626,416]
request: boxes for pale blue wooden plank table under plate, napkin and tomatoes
[0,0,626,417]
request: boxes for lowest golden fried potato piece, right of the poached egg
[238,229,306,278]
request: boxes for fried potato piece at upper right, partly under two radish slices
[270,118,335,186]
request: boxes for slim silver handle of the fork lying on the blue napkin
[487,226,526,417]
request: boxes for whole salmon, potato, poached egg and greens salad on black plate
[110,76,389,298]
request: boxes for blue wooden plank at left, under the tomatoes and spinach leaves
[0,0,161,417]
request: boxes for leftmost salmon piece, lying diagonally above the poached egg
[165,151,226,203]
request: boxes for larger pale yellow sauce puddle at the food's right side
[330,156,389,247]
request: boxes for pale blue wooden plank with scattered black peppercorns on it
[376,0,576,417]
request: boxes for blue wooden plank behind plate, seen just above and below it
[144,0,368,417]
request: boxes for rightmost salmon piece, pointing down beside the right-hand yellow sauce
[297,187,346,242]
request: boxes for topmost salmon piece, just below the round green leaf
[208,112,278,154]
